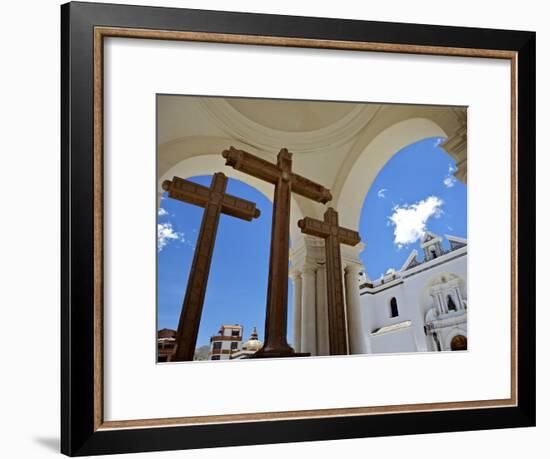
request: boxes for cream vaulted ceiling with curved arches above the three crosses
[157,95,466,235]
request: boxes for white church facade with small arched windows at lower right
[360,232,468,353]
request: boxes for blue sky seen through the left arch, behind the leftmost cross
[157,174,292,358]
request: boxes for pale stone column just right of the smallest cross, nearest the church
[345,264,368,354]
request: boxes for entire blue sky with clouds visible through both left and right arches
[158,138,466,346]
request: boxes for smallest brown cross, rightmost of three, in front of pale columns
[298,207,361,355]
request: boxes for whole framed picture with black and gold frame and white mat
[61,2,535,456]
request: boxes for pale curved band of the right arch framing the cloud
[333,118,447,228]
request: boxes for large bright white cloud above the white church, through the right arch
[388,196,443,248]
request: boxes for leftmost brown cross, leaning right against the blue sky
[162,172,260,362]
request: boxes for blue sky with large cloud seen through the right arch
[359,138,467,280]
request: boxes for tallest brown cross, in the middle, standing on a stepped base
[222,147,332,357]
